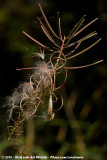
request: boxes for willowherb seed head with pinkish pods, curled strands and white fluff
[8,4,103,158]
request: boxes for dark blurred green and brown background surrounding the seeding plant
[0,0,107,160]
